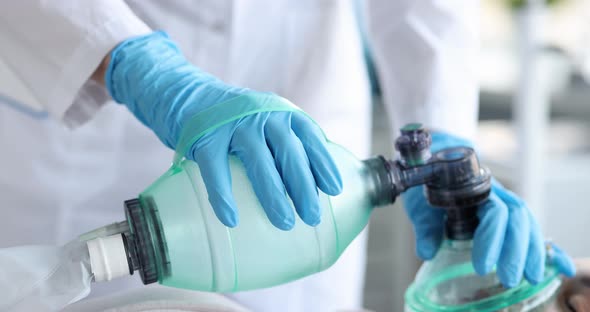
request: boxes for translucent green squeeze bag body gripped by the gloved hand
[140,143,372,292]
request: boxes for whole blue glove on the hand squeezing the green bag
[105,32,342,230]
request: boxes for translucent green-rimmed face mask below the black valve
[405,241,561,312]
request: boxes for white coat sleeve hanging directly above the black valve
[365,0,479,139]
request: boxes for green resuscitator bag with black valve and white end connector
[0,124,560,311]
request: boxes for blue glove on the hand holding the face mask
[402,132,575,287]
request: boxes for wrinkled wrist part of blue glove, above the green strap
[105,32,225,148]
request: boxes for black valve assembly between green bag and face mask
[387,123,491,240]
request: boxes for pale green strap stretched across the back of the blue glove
[174,93,303,164]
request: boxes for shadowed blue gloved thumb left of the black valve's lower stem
[402,186,445,260]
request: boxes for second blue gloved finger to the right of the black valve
[492,187,531,287]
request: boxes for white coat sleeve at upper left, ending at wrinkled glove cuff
[0,0,150,127]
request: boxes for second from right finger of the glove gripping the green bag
[264,112,321,226]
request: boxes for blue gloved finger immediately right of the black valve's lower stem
[472,192,508,275]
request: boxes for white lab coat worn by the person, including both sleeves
[0,0,477,311]
